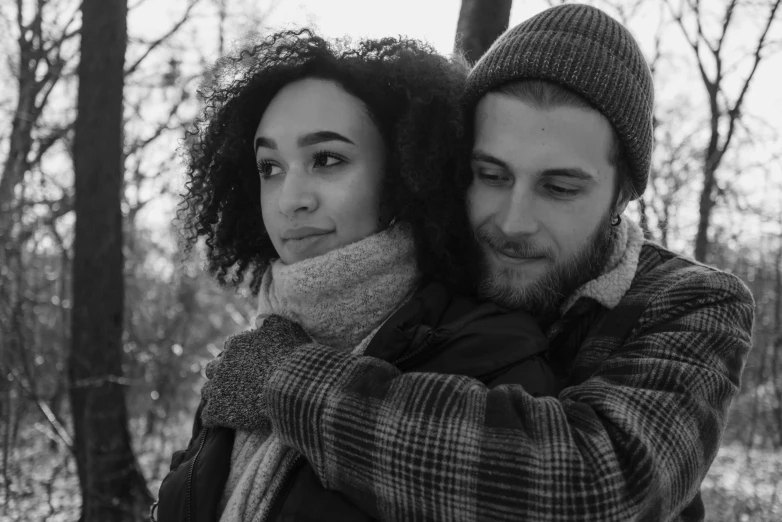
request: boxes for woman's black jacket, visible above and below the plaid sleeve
[156,283,564,522]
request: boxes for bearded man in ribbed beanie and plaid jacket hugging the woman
[202,5,753,521]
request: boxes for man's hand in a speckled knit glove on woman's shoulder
[201,315,312,431]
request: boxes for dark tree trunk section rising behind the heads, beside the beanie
[454,0,513,63]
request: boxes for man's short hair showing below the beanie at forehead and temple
[500,80,639,204]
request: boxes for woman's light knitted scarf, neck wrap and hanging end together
[220,225,419,522]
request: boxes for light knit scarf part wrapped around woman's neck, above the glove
[256,224,419,350]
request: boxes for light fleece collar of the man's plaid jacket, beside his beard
[560,214,644,315]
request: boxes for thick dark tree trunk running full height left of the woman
[68,0,151,522]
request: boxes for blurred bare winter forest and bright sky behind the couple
[0,0,782,522]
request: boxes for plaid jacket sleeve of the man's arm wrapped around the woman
[267,269,754,522]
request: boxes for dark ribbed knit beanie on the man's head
[466,4,654,195]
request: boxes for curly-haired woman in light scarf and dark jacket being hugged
[158,30,558,522]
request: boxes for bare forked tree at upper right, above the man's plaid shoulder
[667,0,782,261]
